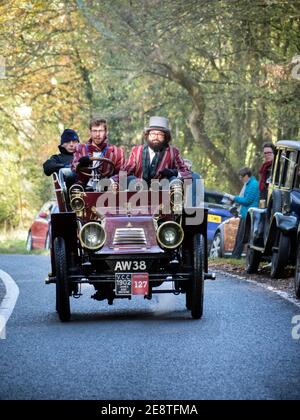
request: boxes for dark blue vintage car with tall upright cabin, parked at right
[244,140,300,278]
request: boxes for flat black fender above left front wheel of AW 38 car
[50,212,79,274]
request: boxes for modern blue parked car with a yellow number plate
[204,190,232,248]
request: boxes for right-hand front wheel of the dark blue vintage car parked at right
[271,233,291,279]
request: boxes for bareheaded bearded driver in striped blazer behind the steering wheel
[72,118,125,187]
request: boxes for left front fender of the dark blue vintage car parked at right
[243,207,267,248]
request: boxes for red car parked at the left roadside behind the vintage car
[26,200,58,251]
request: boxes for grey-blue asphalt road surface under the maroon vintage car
[0,255,300,400]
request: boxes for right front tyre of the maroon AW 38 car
[191,233,204,319]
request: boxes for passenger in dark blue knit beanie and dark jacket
[43,128,79,187]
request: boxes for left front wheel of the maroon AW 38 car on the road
[54,238,71,322]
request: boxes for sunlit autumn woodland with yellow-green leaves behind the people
[0,0,300,229]
